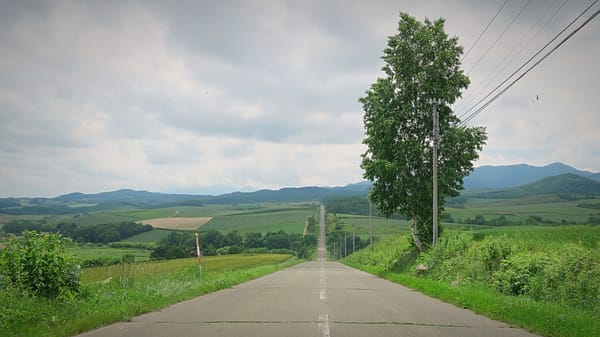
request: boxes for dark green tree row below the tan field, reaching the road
[150,230,317,260]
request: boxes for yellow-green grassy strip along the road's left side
[0,254,301,337]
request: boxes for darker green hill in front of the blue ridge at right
[473,173,600,199]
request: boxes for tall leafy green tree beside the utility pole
[359,13,487,251]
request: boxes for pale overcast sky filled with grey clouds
[0,0,600,197]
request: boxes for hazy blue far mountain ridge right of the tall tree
[464,163,600,190]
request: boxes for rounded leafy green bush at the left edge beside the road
[0,231,81,299]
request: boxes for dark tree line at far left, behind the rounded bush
[2,219,152,243]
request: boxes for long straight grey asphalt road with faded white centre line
[79,208,535,337]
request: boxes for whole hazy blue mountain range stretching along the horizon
[0,163,600,214]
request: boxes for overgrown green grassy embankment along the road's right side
[343,226,600,337]
